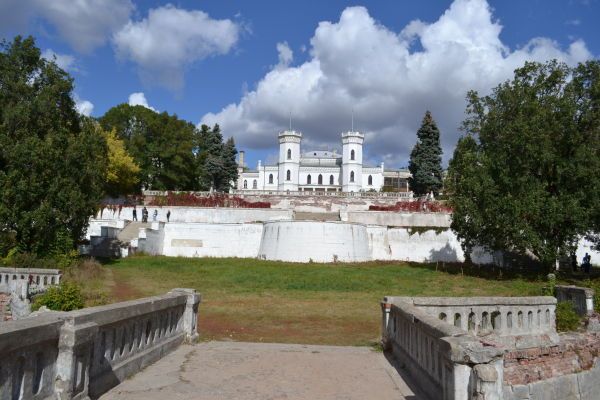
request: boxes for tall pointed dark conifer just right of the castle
[408,111,442,196]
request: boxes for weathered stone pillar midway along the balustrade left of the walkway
[54,317,98,400]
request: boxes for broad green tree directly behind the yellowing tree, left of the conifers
[99,104,198,190]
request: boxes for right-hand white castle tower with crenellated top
[342,131,365,192]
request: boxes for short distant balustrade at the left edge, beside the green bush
[0,267,62,293]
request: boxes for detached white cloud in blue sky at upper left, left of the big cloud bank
[113,5,240,90]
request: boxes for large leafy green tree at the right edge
[446,61,600,267]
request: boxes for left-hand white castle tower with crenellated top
[277,130,302,191]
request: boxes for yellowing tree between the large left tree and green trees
[103,126,140,196]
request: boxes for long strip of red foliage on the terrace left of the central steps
[148,192,271,208]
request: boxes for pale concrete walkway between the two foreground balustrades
[101,342,420,400]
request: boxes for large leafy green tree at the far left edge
[0,36,107,256]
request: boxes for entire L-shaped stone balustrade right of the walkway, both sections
[381,296,559,400]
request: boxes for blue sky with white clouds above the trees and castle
[0,0,600,167]
